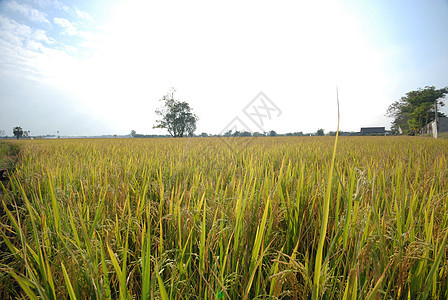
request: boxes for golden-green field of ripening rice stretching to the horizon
[0,137,448,299]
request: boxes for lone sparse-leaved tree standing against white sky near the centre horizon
[154,89,198,137]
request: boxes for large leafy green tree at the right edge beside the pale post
[386,86,448,134]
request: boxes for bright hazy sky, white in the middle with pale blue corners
[0,0,448,135]
